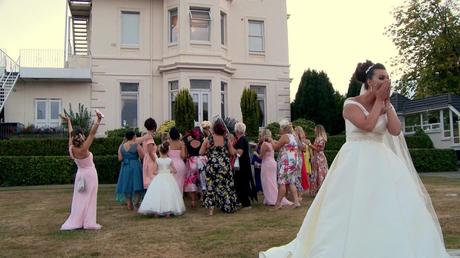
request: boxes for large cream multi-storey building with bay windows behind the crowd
[0,0,290,131]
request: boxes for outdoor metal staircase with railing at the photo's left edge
[0,49,19,112]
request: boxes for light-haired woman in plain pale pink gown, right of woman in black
[260,129,292,205]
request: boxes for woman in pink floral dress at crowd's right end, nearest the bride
[309,125,328,196]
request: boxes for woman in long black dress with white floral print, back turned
[200,121,240,216]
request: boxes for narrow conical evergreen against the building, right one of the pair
[240,88,260,136]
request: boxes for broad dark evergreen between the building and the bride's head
[291,69,337,133]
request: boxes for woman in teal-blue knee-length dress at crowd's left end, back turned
[116,131,144,210]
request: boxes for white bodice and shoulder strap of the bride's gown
[343,99,388,141]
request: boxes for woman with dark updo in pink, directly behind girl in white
[142,117,158,189]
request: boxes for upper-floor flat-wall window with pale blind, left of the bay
[121,11,140,47]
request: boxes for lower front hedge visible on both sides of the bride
[324,149,457,173]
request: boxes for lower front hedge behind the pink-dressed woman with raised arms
[0,155,120,186]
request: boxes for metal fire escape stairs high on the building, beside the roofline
[67,0,92,56]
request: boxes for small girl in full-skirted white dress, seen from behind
[138,142,185,216]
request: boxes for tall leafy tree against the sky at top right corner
[386,0,460,98]
